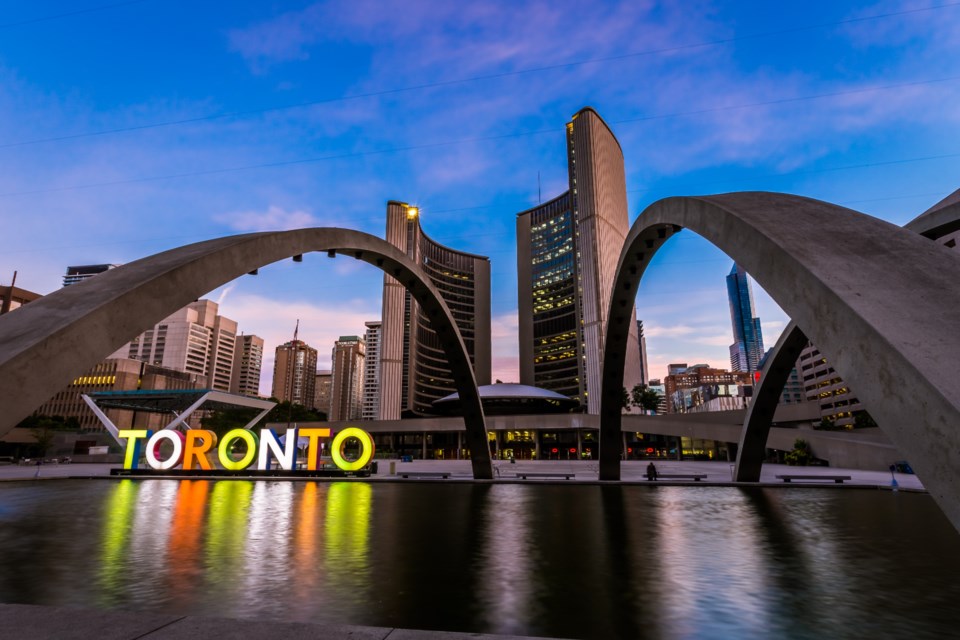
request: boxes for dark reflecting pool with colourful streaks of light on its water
[0,480,960,640]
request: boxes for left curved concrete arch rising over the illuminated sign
[0,228,493,479]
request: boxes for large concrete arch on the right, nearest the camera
[600,192,960,528]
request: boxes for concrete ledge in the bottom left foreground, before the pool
[0,604,568,640]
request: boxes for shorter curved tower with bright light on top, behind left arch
[379,201,490,420]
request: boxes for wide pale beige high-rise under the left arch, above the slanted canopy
[111,300,237,391]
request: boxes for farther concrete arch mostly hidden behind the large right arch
[734,190,960,482]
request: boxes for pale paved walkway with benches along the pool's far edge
[0,460,924,491]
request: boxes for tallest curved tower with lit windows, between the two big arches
[517,108,643,414]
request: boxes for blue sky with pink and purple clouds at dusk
[0,0,960,393]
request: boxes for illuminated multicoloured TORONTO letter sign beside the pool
[118,427,374,471]
